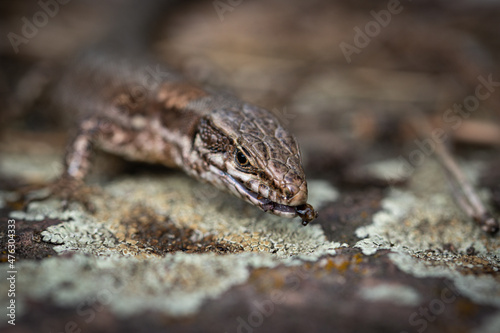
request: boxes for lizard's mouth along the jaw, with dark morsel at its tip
[213,169,318,226]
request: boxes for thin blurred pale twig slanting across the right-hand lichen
[411,112,499,234]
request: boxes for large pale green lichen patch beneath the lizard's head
[0,149,340,321]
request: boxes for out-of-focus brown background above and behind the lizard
[0,0,500,189]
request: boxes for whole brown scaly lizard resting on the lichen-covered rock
[21,0,317,225]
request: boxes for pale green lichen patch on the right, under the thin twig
[355,162,500,306]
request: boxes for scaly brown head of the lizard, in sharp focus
[194,104,317,225]
